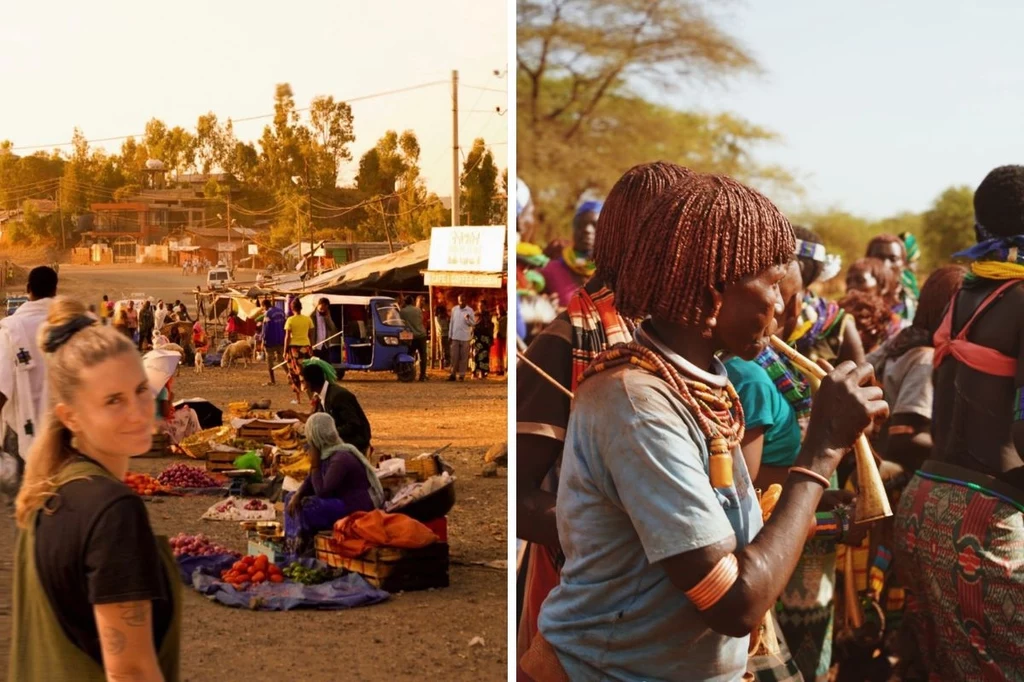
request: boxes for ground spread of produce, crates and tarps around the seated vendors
[140,393,455,610]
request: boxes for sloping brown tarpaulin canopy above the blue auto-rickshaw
[279,240,430,294]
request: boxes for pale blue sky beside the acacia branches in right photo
[676,0,1024,217]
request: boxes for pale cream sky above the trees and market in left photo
[0,0,508,196]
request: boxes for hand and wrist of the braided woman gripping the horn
[799,363,889,478]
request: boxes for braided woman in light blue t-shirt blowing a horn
[519,171,887,682]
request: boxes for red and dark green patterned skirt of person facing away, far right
[896,462,1024,681]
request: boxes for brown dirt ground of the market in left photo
[0,266,508,682]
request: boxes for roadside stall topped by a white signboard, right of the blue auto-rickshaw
[423,225,508,367]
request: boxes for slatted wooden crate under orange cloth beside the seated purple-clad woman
[315,531,449,592]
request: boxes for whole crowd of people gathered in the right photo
[516,163,1024,682]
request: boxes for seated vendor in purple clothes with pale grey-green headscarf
[285,413,384,555]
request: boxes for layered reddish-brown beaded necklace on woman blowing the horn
[581,341,744,487]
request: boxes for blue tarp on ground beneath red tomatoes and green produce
[178,554,391,611]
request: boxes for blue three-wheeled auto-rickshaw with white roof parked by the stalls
[301,294,416,382]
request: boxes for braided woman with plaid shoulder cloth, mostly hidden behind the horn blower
[516,162,691,654]
